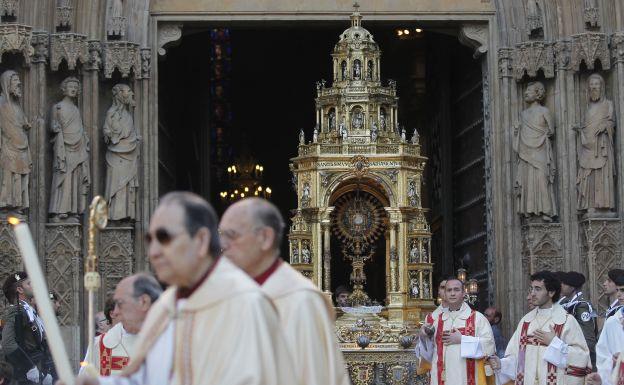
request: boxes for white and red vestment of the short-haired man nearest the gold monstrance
[417,303,496,385]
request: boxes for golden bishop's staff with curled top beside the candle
[83,195,108,376]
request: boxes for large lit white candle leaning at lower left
[9,218,75,385]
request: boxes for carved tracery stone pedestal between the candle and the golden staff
[45,223,84,368]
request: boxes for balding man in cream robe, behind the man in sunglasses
[219,198,350,385]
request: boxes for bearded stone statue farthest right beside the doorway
[575,74,615,215]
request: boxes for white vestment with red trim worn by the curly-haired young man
[496,304,591,385]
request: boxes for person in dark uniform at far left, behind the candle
[2,272,55,384]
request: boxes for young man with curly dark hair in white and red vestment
[490,271,590,385]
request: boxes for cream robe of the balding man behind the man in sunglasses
[262,262,350,385]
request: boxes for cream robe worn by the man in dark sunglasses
[100,257,299,385]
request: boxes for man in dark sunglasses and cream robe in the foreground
[67,192,298,385]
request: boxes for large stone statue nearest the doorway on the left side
[103,84,141,220]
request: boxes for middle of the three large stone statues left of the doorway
[49,77,91,223]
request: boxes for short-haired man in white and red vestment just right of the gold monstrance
[418,279,495,385]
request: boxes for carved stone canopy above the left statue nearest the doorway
[103,41,142,78]
